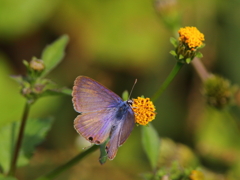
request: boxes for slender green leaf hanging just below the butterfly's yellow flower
[142,124,160,170]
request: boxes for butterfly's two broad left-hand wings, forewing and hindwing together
[72,76,122,144]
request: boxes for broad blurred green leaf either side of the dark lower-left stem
[0,118,53,173]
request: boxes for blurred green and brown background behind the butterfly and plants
[0,0,240,180]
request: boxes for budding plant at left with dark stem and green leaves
[0,35,71,179]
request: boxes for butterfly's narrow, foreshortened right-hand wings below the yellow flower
[106,107,135,160]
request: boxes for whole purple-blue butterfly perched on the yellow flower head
[72,76,135,160]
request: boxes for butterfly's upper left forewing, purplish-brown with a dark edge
[72,76,122,113]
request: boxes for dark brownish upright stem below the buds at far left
[8,101,30,176]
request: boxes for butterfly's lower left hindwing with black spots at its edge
[74,109,116,144]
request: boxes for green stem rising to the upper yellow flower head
[151,62,184,102]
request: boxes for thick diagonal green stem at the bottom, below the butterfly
[36,145,99,180]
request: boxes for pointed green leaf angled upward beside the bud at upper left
[41,35,69,77]
